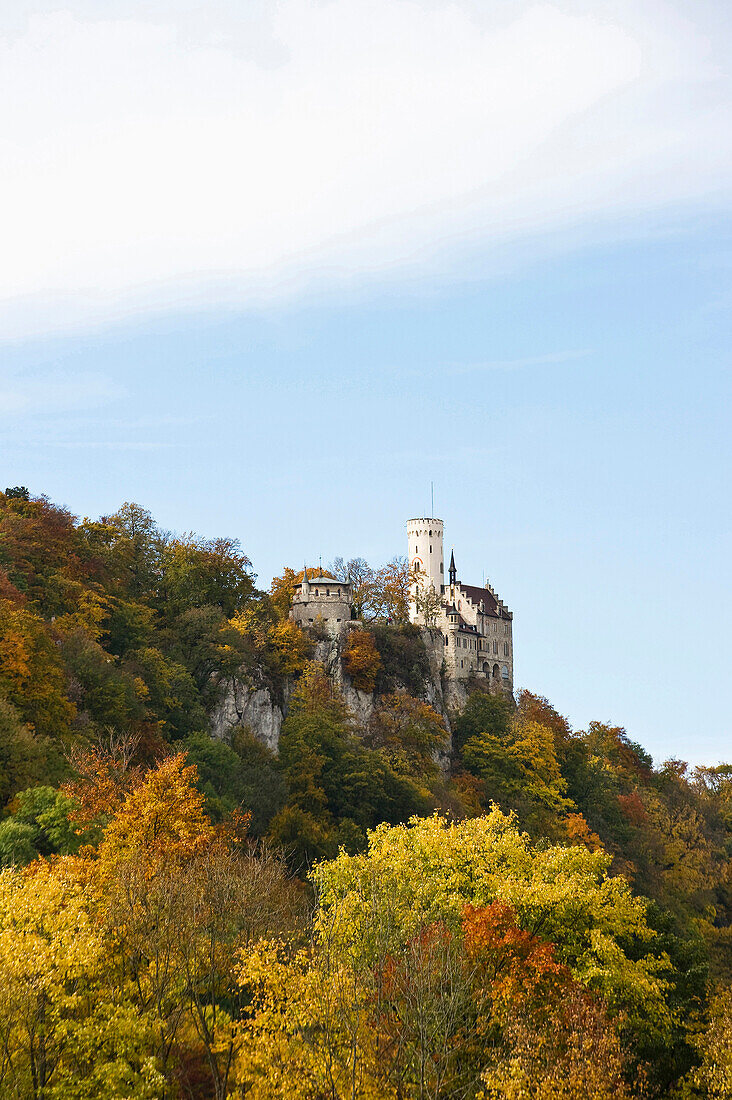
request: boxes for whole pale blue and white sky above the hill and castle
[0,0,732,763]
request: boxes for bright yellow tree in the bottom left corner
[0,862,164,1100]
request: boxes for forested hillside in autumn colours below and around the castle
[0,487,732,1100]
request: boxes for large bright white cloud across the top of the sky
[0,0,730,337]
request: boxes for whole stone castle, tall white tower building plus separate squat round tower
[292,517,513,691]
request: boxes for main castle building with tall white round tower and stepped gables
[407,517,513,691]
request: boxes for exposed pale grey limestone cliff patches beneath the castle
[210,624,451,752]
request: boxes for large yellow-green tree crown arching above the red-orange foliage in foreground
[313,809,670,1056]
